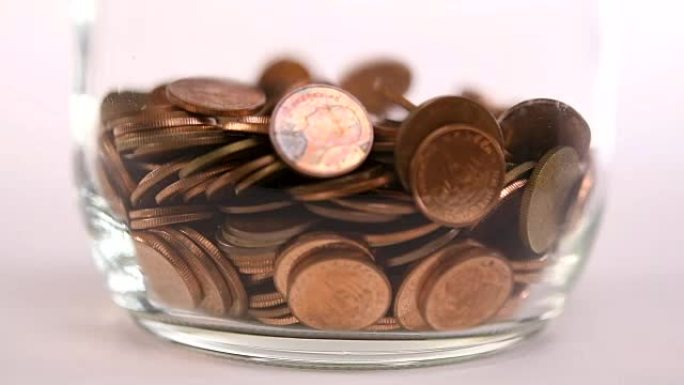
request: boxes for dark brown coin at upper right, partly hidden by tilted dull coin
[499,99,591,162]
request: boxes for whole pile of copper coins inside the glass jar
[95,60,594,331]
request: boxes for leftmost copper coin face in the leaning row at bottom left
[132,232,203,310]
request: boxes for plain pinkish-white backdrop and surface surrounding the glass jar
[0,0,684,384]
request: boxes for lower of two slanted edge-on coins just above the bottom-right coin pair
[376,229,460,268]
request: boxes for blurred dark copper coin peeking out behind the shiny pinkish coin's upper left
[258,58,311,98]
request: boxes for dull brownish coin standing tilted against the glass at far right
[520,147,581,254]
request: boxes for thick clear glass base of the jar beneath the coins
[133,312,550,369]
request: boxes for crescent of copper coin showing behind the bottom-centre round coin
[273,232,372,295]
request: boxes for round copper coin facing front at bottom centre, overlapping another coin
[287,248,392,330]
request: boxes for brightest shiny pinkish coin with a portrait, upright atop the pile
[270,84,373,178]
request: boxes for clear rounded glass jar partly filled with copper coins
[72,0,614,367]
